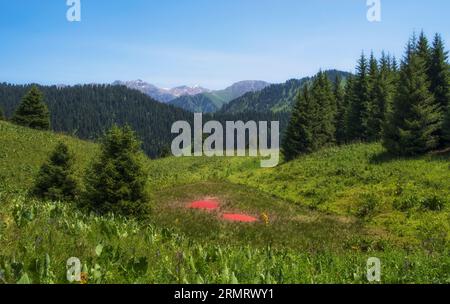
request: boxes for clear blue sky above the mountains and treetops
[0,0,450,89]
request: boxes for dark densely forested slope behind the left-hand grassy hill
[0,84,192,157]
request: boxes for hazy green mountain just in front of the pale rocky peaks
[169,80,270,113]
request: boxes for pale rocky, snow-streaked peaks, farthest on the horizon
[112,79,211,103]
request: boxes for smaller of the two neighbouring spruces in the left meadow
[32,143,78,201]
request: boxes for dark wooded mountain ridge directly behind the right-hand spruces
[220,70,350,114]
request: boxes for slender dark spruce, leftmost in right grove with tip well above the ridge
[348,54,370,140]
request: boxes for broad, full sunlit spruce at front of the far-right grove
[383,40,440,156]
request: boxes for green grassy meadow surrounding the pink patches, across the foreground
[0,122,450,283]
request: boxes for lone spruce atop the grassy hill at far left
[12,86,50,130]
